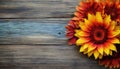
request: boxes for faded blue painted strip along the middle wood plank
[0,21,66,37]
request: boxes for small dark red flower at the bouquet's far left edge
[66,20,79,45]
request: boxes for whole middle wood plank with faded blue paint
[0,18,69,44]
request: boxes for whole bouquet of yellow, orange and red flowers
[66,0,120,68]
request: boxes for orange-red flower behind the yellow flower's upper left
[72,0,103,21]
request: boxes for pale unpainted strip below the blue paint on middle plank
[0,35,67,45]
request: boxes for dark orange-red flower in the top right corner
[103,0,120,21]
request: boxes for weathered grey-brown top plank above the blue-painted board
[0,0,79,19]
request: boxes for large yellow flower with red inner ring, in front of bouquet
[75,12,120,59]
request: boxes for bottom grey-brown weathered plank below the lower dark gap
[0,45,104,69]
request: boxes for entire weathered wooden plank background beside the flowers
[0,0,108,69]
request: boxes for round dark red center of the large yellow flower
[90,27,108,44]
